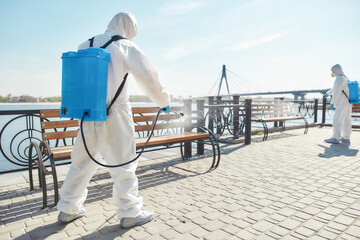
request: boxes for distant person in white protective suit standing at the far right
[325,64,352,143]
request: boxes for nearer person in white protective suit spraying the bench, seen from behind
[57,12,170,228]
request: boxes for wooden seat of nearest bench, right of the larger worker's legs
[136,132,209,148]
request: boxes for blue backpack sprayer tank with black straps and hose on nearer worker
[60,35,173,168]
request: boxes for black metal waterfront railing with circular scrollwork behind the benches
[0,96,332,174]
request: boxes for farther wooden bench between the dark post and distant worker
[251,101,309,140]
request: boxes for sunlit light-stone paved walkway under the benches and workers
[0,128,360,240]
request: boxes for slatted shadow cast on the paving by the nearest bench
[0,157,212,226]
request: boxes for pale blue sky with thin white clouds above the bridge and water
[0,0,360,97]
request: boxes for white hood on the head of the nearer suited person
[105,12,137,40]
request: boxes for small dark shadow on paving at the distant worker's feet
[318,143,359,158]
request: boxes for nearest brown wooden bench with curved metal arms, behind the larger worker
[29,107,220,208]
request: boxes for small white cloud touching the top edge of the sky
[160,0,206,15]
